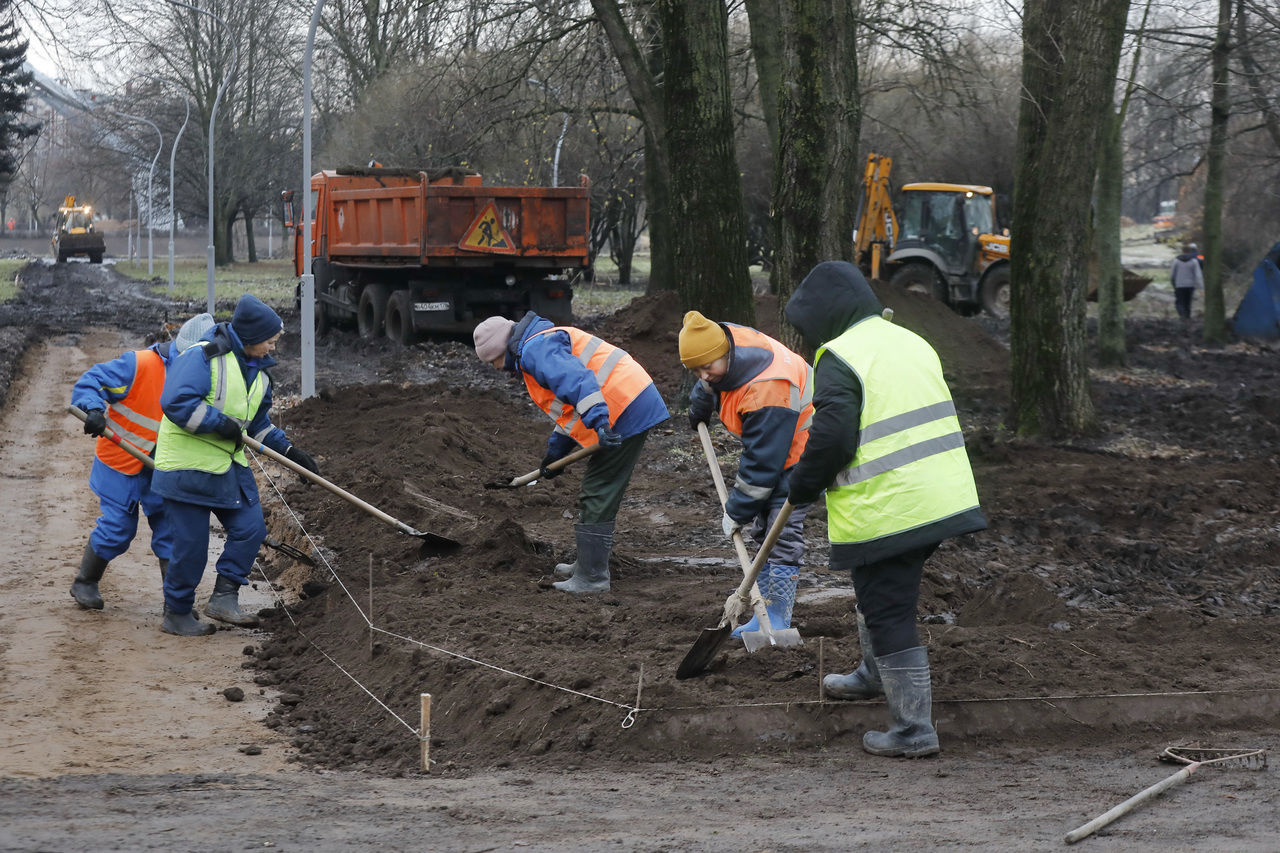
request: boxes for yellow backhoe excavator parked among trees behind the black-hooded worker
[854,154,1009,316]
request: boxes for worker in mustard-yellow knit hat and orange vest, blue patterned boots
[680,311,813,637]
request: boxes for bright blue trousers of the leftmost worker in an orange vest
[88,456,173,562]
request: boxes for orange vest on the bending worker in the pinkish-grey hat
[520,325,653,447]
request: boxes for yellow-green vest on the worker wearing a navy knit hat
[156,342,271,474]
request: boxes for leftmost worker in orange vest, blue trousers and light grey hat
[72,314,214,610]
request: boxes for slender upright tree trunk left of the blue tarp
[1204,0,1231,343]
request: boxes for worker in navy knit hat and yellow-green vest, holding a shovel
[152,293,320,637]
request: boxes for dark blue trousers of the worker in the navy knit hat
[164,498,266,615]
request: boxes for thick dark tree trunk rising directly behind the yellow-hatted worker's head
[650,0,755,325]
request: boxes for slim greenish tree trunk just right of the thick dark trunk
[1093,110,1126,368]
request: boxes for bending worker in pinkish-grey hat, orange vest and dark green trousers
[474,311,671,596]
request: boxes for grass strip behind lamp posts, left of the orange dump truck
[115,257,298,307]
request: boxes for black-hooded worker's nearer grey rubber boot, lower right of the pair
[863,646,938,758]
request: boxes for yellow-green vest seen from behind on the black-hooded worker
[814,316,978,544]
